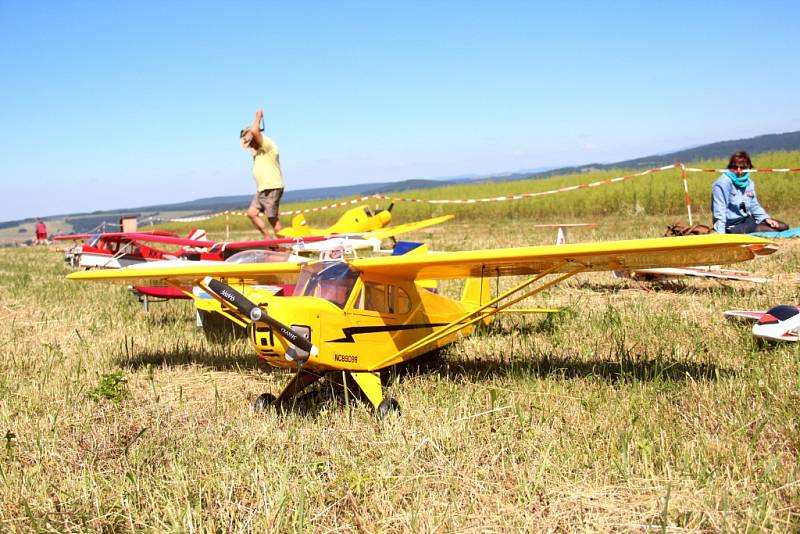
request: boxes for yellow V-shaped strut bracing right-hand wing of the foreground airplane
[367,261,586,371]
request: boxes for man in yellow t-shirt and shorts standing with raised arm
[239,109,283,237]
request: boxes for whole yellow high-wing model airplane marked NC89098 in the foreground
[67,234,775,414]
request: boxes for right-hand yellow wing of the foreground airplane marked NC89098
[350,234,776,280]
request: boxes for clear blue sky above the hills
[0,0,800,220]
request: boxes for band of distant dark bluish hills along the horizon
[0,131,800,232]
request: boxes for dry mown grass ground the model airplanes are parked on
[0,170,800,532]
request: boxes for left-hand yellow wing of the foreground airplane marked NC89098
[67,261,300,286]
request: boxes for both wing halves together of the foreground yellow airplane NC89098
[67,234,777,284]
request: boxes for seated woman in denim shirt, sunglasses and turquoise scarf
[711,152,789,234]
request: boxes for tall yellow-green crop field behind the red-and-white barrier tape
[159,151,800,238]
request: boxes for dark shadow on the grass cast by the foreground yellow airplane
[114,340,736,417]
